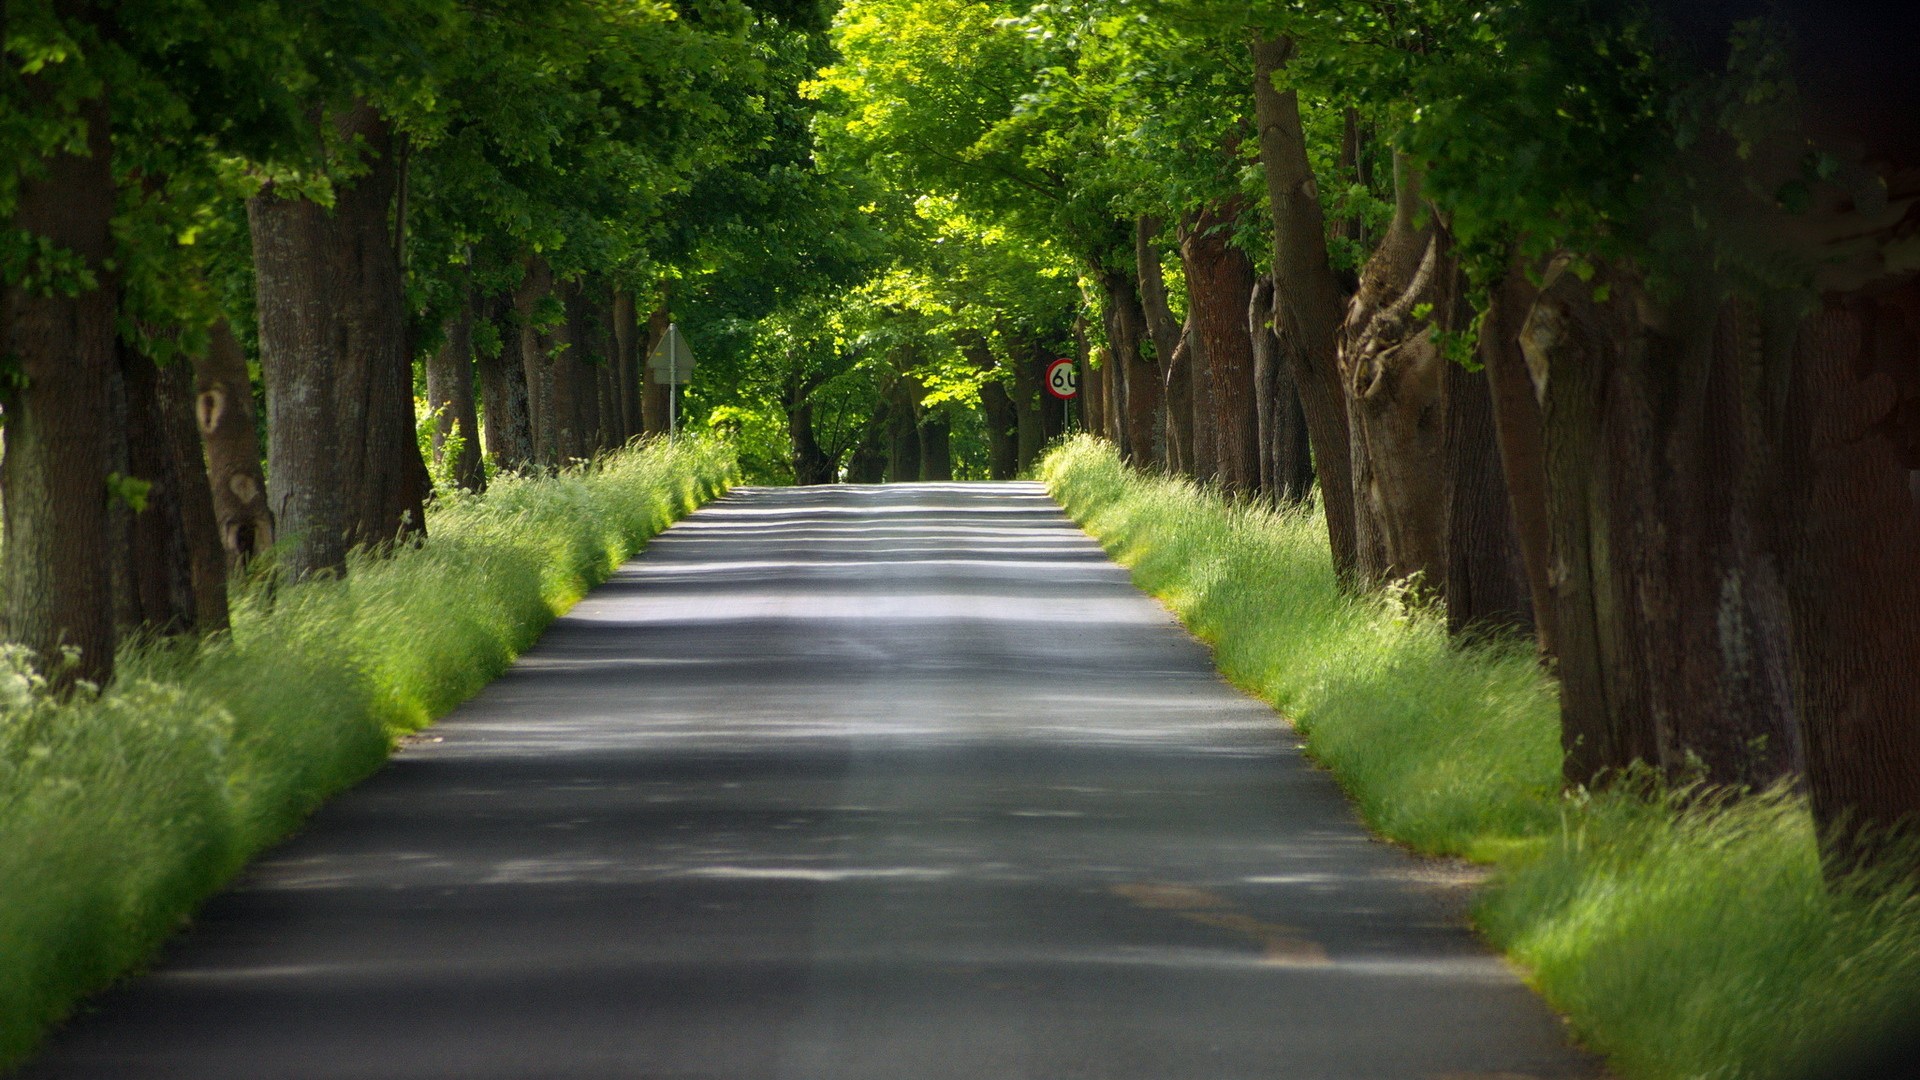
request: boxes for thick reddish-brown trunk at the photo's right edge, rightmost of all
[1782,284,1920,872]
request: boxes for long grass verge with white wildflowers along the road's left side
[0,440,733,1070]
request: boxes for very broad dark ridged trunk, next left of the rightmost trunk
[1521,255,1799,788]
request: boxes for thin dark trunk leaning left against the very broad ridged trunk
[1480,263,1557,661]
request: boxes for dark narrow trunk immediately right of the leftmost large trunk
[108,342,205,638]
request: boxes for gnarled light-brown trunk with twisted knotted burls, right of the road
[1340,154,1461,590]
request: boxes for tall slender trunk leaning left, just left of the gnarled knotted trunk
[1250,37,1357,582]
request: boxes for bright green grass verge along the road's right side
[1039,438,1920,1080]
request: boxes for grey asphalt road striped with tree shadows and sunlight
[27,484,1597,1080]
